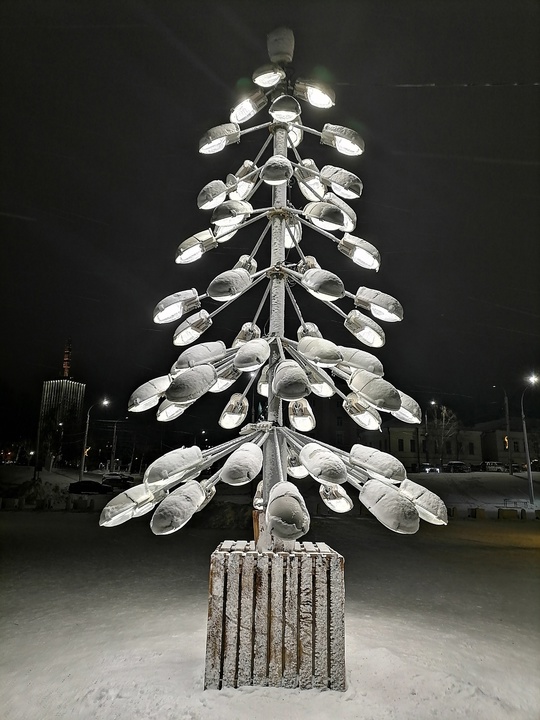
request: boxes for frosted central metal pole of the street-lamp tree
[258,125,287,551]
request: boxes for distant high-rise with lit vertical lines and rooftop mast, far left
[36,342,86,471]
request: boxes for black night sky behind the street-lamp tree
[0,0,540,441]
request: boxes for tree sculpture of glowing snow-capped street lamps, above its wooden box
[100,28,447,687]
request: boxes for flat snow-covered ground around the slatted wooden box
[0,504,540,720]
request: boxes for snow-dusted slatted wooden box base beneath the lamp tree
[204,541,345,690]
